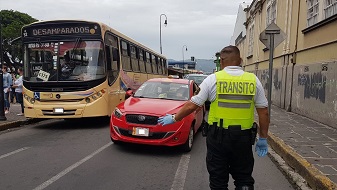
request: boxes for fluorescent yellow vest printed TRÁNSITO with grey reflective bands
[208,70,256,130]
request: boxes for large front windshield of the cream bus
[24,38,106,82]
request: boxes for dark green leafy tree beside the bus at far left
[0,10,37,65]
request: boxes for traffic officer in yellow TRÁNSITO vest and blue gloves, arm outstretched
[158,46,269,190]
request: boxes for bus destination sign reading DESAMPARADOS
[22,24,101,37]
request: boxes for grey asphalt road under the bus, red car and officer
[0,120,293,190]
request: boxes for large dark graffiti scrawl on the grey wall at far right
[297,72,326,103]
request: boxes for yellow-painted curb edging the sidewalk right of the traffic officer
[268,132,337,190]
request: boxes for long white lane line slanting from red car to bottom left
[33,142,113,190]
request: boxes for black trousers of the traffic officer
[206,127,254,190]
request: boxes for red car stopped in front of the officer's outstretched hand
[110,78,204,152]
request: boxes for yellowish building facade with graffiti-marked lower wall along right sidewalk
[233,0,337,128]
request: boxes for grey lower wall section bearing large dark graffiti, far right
[291,60,337,128]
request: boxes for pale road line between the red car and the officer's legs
[171,154,191,190]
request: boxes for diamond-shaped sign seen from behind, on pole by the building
[259,22,286,49]
